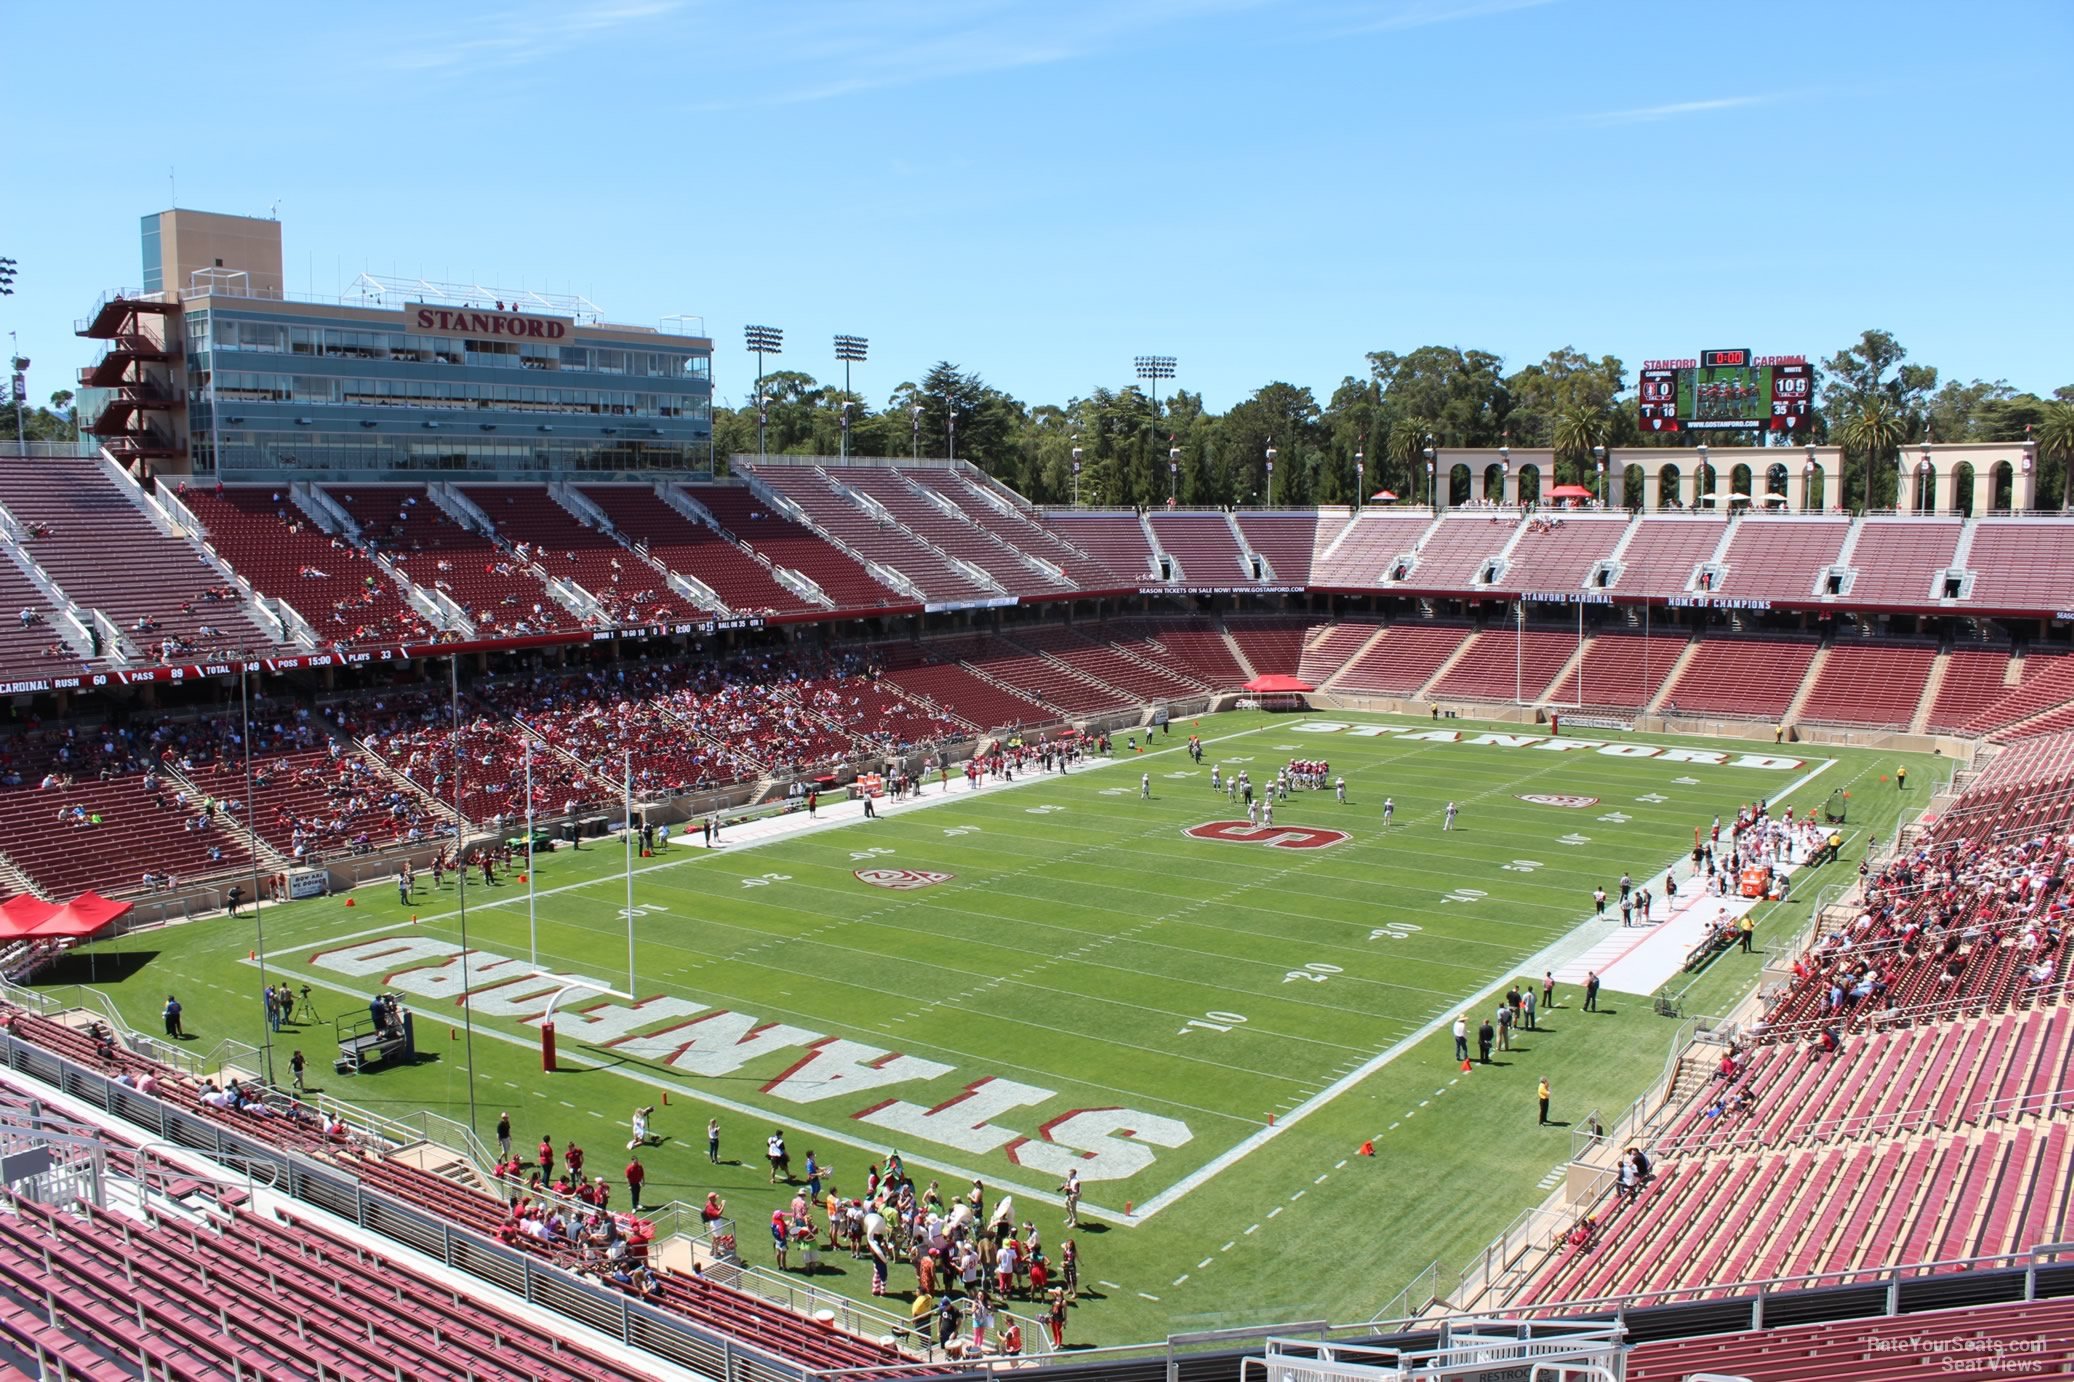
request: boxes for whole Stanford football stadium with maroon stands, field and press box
[0,24,2074,1382]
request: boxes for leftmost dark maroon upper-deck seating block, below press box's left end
[187,486,437,645]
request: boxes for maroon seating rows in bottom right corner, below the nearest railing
[1626,1301,2074,1382]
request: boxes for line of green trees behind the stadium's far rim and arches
[713,330,2074,508]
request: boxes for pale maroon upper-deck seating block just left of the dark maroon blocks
[0,457,272,668]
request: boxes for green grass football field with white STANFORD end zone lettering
[46,714,1943,1343]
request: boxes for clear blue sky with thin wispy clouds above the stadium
[0,0,2074,409]
